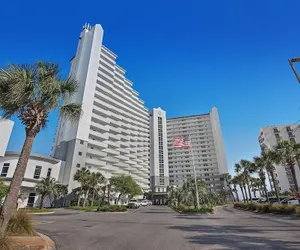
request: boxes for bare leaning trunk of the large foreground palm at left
[0,133,35,233]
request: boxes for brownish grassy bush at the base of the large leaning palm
[6,209,33,234]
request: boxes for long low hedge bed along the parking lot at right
[233,203,300,216]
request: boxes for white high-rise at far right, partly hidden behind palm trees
[258,124,300,192]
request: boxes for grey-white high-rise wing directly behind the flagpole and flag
[167,107,228,191]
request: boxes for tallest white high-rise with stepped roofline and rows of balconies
[52,24,150,191]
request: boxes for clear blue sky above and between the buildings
[0,0,300,175]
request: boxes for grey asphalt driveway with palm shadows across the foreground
[35,206,300,250]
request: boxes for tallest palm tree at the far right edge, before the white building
[273,141,299,193]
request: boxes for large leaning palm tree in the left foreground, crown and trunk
[0,62,81,233]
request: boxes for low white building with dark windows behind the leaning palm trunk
[0,151,62,208]
